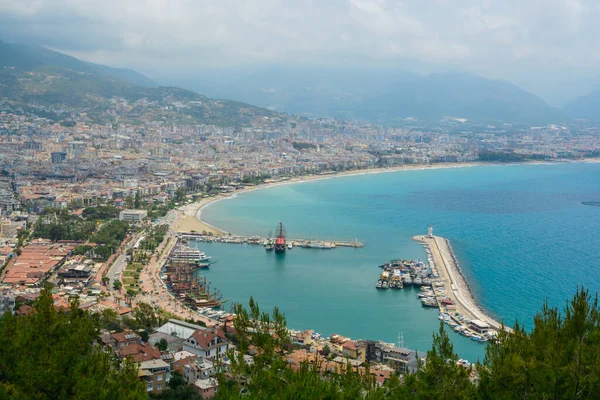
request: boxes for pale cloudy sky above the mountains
[0,0,600,105]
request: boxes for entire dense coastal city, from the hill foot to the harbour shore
[0,87,600,398]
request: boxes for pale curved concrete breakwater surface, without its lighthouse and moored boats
[413,235,510,330]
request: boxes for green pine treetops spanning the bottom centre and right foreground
[217,289,600,400]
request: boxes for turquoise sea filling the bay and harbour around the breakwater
[199,163,600,361]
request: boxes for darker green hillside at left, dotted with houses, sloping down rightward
[0,42,288,126]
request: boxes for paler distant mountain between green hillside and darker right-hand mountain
[169,66,417,119]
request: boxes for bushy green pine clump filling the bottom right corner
[480,289,600,399]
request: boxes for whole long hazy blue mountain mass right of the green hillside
[171,67,566,124]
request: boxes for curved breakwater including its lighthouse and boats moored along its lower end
[413,227,510,341]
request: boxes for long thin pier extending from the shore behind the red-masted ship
[177,232,364,250]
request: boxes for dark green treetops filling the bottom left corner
[0,290,147,400]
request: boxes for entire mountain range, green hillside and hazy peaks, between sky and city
[0,42,600,125]
